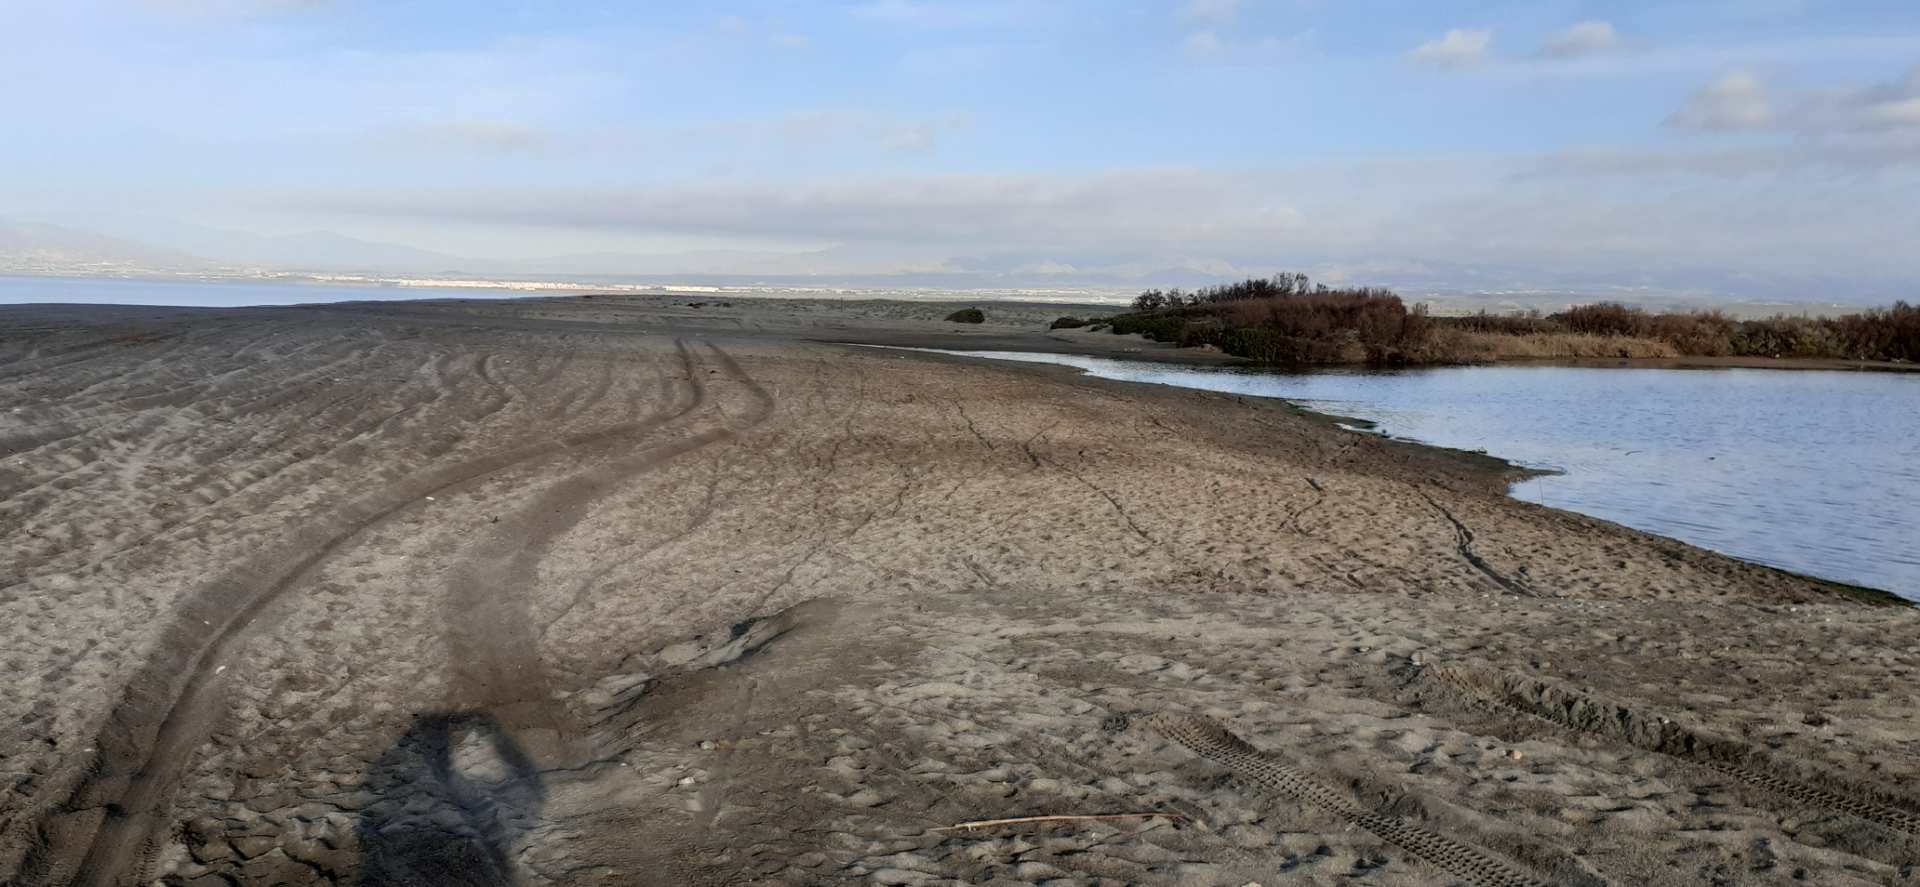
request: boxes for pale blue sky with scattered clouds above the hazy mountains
[0,0,1920,292]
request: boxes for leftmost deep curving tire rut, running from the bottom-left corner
[19,344,706,885]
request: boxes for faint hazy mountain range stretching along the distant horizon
[0,219,1920,313]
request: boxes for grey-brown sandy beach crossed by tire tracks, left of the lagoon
[0,296,1920,887]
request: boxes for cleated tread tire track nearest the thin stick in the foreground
[1146,714,1544,887]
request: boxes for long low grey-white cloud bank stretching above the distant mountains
[282,156,1920,275]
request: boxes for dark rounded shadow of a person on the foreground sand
[353,712,545,887]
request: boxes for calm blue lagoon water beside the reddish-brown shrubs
[940,351,1920,599]
